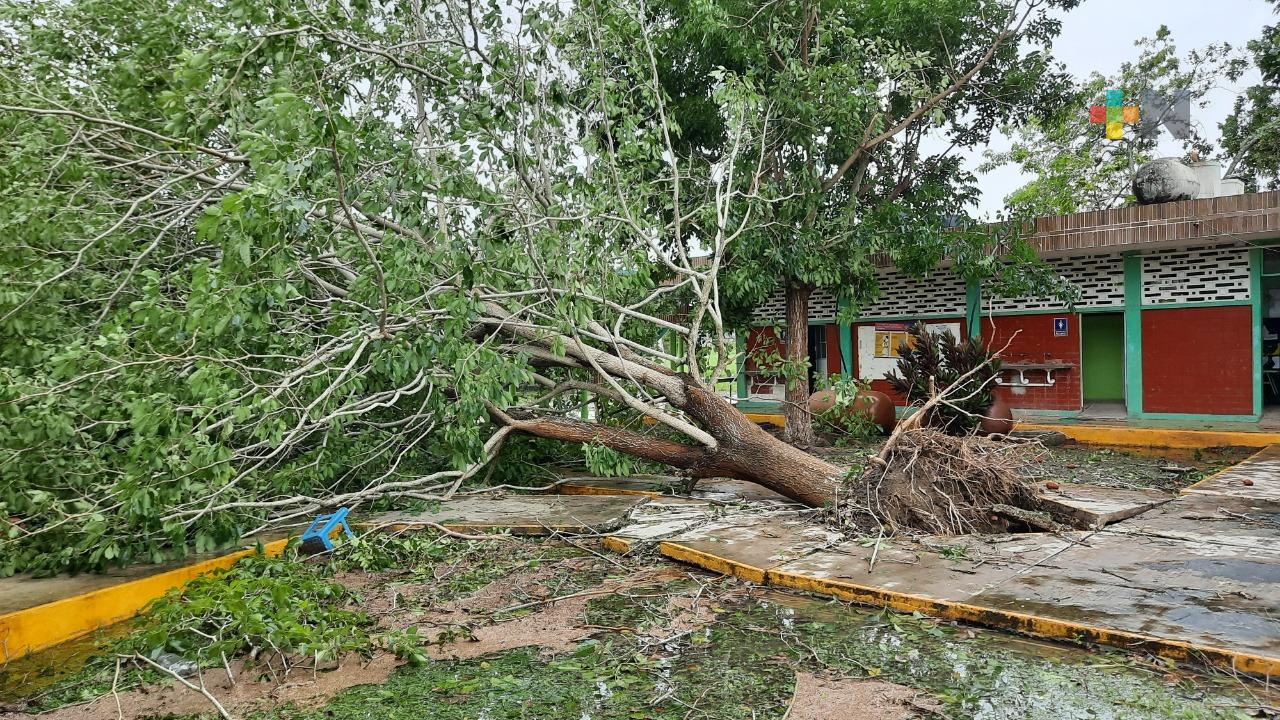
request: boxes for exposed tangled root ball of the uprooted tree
[831,427,1038,534]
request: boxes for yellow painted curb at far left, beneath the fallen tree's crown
[0,539,288,662]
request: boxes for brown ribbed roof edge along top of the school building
[1030,191,1280,255]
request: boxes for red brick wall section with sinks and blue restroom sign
[982,313,1082,410]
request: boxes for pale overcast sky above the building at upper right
[969,0,1280,217]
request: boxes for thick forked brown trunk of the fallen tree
[499,375,845,507]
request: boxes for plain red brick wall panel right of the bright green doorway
[1142,305,1253,415]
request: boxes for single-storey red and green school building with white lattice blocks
[737,192,1280,421]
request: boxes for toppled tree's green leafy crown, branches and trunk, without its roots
[0,0,1049,574]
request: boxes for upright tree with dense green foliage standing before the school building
[629,0,1075,446]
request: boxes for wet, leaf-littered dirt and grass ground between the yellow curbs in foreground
[0,539,1280,720]
